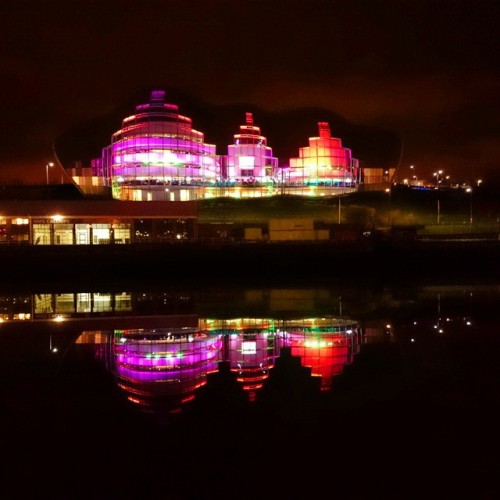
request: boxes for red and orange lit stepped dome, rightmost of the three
[283,122,360,188]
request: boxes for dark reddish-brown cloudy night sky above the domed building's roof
[0,0,500,183]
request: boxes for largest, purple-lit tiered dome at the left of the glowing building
[93,90,220,201]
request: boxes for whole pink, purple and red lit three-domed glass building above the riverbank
[70,90,361,201]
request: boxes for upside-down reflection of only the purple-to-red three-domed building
[77,317,363,416]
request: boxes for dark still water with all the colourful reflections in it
[0,284,500,499]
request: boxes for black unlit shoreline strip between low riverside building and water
[0,239,500,287]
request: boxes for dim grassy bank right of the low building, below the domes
[199,186,500,232]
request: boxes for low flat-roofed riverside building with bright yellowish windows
[0,200,197,245]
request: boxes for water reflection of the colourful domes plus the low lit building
[0,290,376,422]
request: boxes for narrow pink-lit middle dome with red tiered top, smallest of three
[221,113,278,184]
